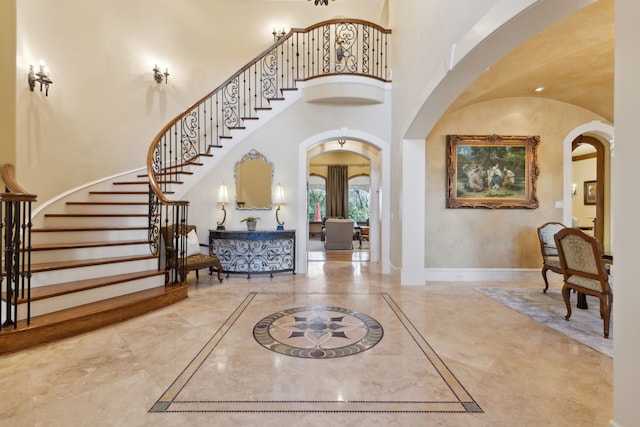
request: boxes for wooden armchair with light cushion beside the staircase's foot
[161,225,224,283]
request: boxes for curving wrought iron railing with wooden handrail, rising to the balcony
[147,19,391,284]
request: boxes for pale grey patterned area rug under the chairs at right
[476,288,613,357]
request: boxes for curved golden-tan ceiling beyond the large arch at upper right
[449,0,615,123]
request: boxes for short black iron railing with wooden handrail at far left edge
[0,164,37,329]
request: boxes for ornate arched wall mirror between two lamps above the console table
[234,149,273,209]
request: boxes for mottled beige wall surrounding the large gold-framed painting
[425,98,602,268]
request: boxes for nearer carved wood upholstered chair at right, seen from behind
[554,228,613,338]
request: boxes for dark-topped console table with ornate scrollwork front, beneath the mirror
[209,230,296,278]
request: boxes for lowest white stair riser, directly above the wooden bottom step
[12,275,164,320]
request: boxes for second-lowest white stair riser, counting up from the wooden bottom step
[31,258,158,287]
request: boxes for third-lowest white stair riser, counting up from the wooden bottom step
[31,243,151,264]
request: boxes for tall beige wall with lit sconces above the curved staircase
[15,0,383,206]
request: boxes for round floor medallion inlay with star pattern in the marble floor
[253,306,384,359]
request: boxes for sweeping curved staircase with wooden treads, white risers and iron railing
[0,20,390,354]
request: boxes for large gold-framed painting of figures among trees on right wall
[447,135,540,209]
